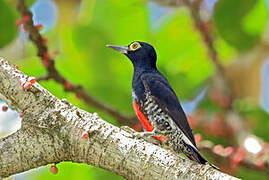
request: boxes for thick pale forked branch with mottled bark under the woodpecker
[0,58,239,180]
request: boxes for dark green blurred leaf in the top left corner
[0,0,18,48]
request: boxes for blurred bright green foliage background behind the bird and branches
[0,0,269,180]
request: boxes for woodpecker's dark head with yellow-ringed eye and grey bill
[107,41,157,70]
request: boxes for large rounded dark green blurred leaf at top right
[211,0,267,51]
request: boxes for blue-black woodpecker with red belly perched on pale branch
[107,41,216,168]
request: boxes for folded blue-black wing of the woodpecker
[141,73,196,147]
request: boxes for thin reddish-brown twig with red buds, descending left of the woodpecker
[17,0,137,126]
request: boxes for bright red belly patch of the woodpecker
[133,101,163,142]
